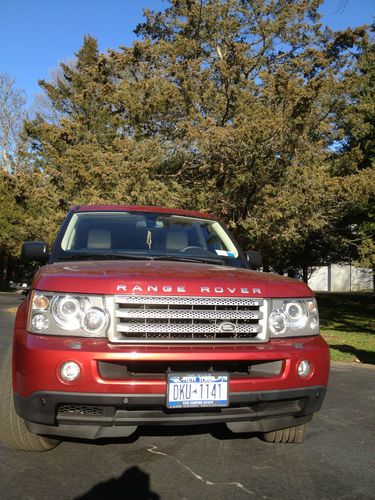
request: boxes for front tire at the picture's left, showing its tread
[0,349,59,451]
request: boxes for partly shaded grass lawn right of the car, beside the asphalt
[316,292,375,364]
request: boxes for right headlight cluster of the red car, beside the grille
[268,298,319,338]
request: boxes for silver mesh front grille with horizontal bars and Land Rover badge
[110,295,267,343]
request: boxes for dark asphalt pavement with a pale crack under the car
[0,293,375,500]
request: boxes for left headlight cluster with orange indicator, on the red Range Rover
[28,291,109,337]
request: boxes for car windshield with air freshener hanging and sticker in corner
[58,212,245,267]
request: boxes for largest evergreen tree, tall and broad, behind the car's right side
[112,0,366,270]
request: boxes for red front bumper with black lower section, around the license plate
[13,328,329,439]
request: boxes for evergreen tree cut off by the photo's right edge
[333,31,375,270]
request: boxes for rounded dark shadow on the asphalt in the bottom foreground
[76,466,160,500]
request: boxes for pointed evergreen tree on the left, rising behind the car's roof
[25,36,187,241]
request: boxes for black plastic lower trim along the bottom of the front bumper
[14,386,326,426]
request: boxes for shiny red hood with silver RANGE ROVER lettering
[33,261,313,297]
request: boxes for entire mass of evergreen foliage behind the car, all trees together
[7,0,375,269]
